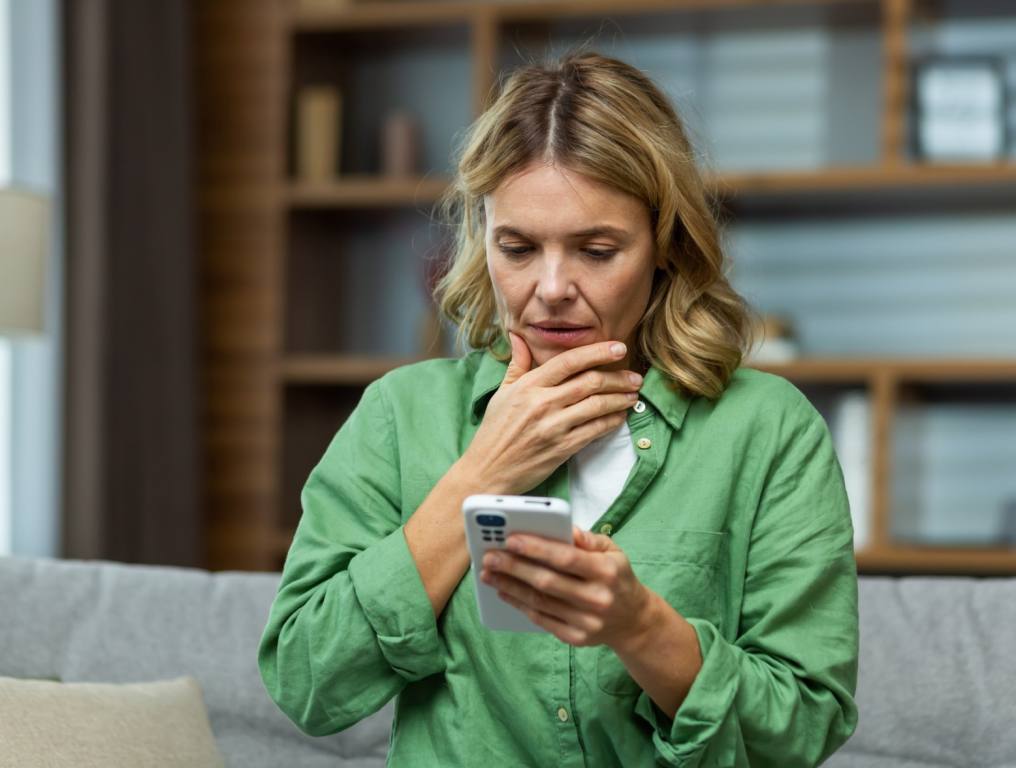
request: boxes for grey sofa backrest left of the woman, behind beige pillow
[0,557,394,768]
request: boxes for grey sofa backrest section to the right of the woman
[824,576,1016,768]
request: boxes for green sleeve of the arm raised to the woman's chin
[258,381,445,735]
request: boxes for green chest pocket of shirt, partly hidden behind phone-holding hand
[596,528,726,696]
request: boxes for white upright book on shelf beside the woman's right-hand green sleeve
[830,391,872,552]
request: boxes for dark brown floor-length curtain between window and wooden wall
[62,0,204,566]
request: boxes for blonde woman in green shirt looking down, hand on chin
[259,53,858,768]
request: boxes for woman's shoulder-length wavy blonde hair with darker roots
[434,50,758,398]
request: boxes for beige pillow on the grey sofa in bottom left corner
[0,676,223,768]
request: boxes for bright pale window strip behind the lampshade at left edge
[0,0,63,557]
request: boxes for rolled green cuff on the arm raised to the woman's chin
[347,525,445,682]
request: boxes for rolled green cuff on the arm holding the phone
[635,618,738,767]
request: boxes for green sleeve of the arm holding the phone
[635,395,859,768]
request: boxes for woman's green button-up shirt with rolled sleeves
[258,343,859,768]
